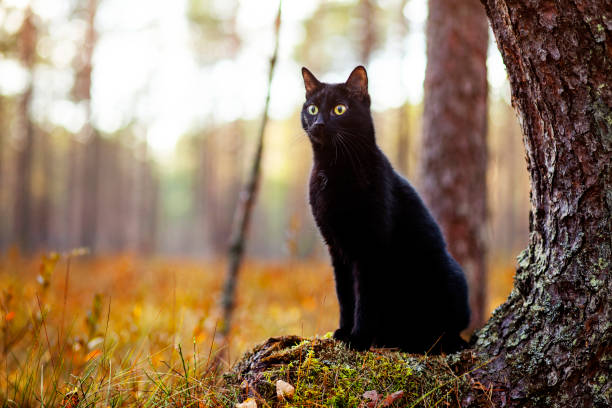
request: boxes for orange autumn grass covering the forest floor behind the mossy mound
[0,251,514,408]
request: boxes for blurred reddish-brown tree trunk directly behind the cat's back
[421,0,488,327]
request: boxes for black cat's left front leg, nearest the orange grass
[330,249,355,342]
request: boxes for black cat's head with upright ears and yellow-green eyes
[301,66,374,148]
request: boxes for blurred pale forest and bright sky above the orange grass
[0,0,529,316]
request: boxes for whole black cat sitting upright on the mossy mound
[301,66,470,353]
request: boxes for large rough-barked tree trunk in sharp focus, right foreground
[476,0,612,407]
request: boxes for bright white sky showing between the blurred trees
[0,0,506,156]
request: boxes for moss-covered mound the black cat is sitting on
[225,336,486,407]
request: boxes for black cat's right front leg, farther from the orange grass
[348,261,377,351]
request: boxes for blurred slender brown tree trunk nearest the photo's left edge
[13,7,37,253]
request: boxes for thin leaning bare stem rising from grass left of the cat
[220,1,282,339]
